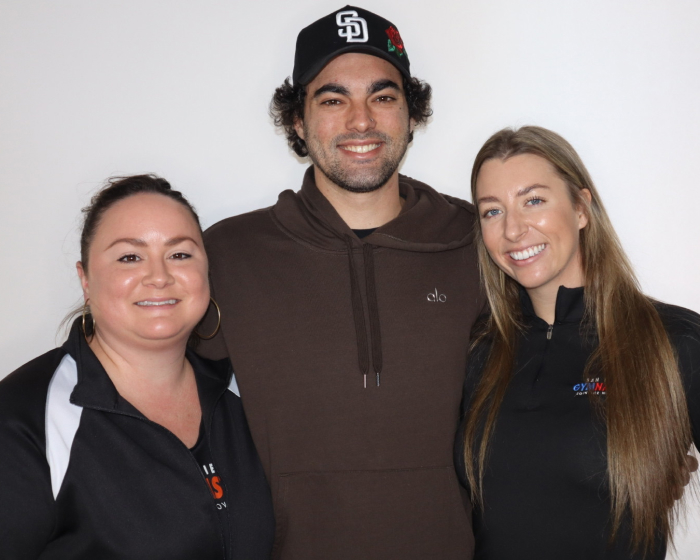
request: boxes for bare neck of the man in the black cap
[314,167,403,229]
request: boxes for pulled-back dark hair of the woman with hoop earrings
[80,174,202,272]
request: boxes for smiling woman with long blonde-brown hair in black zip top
[457,127,700,560]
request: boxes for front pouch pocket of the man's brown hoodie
[273,466,473,560]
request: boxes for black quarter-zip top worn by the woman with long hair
[455,287,700,560]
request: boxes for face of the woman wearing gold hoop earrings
[78,193,209,347]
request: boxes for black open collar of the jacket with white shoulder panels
[63,318,233,426]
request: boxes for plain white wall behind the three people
[0,0,700,558]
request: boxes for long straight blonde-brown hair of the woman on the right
[464,126,692,553]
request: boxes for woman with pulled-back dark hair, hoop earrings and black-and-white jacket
[0,175,274,560]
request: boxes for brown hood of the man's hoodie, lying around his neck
[272,166,476,253]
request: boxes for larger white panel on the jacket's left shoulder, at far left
[46,354,83,499]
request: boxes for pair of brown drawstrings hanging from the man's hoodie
[345,235,383,388]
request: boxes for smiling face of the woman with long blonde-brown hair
[476,154,590,299]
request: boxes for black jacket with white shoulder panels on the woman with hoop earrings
[0,323,274,560]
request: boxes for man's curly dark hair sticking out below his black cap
[270,77,433,157]
